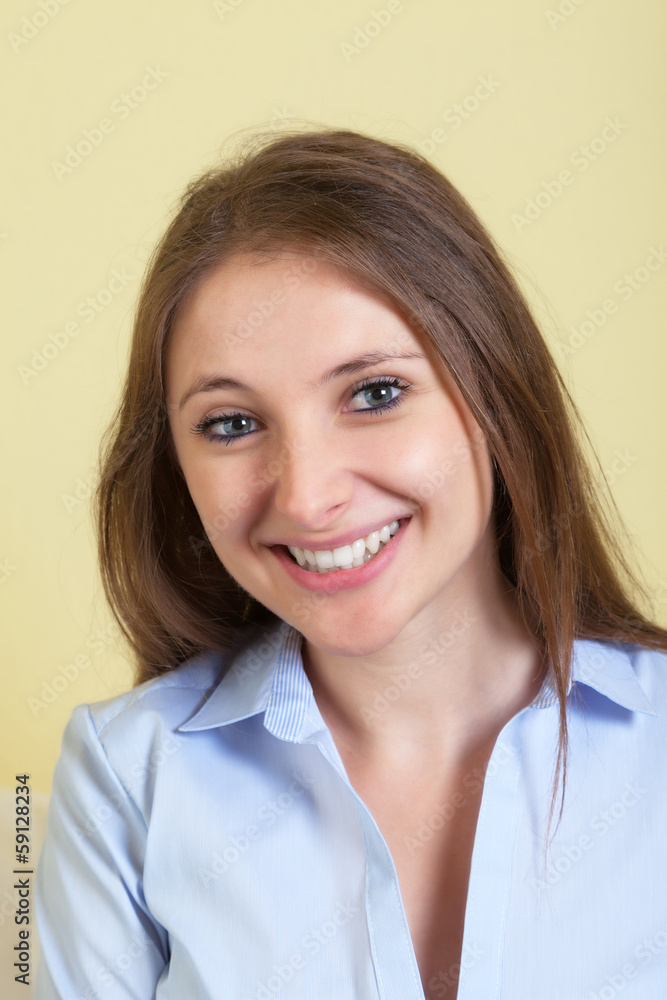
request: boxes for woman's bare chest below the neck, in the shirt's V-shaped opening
[347,760,484,1000]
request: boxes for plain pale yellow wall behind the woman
[0,0,667,792]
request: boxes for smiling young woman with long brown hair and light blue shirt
[36,129,667,1000]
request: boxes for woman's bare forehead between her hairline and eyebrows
[166,251,425,382]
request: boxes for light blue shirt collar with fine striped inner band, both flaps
[178,622,658,742]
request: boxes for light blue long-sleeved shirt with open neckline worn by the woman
[35,623,667,1000]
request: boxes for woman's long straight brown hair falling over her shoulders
[95,128,667,836]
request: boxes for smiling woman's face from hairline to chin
[165,253,495,655]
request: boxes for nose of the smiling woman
[269,431,354,531]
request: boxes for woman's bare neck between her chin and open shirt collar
[302,571,546,769]
